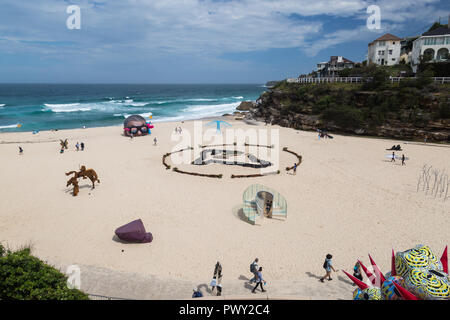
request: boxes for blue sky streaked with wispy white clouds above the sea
[0,0,450,83]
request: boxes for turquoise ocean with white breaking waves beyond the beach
[0,84,266,132]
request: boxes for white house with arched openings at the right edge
[411,19,450,72]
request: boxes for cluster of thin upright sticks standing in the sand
[417,164,450,201]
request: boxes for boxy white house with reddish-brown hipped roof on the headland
[367,33,402,66]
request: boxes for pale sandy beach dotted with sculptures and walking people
[0,118,450,299]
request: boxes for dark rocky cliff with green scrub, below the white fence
[238,83,450,142]
